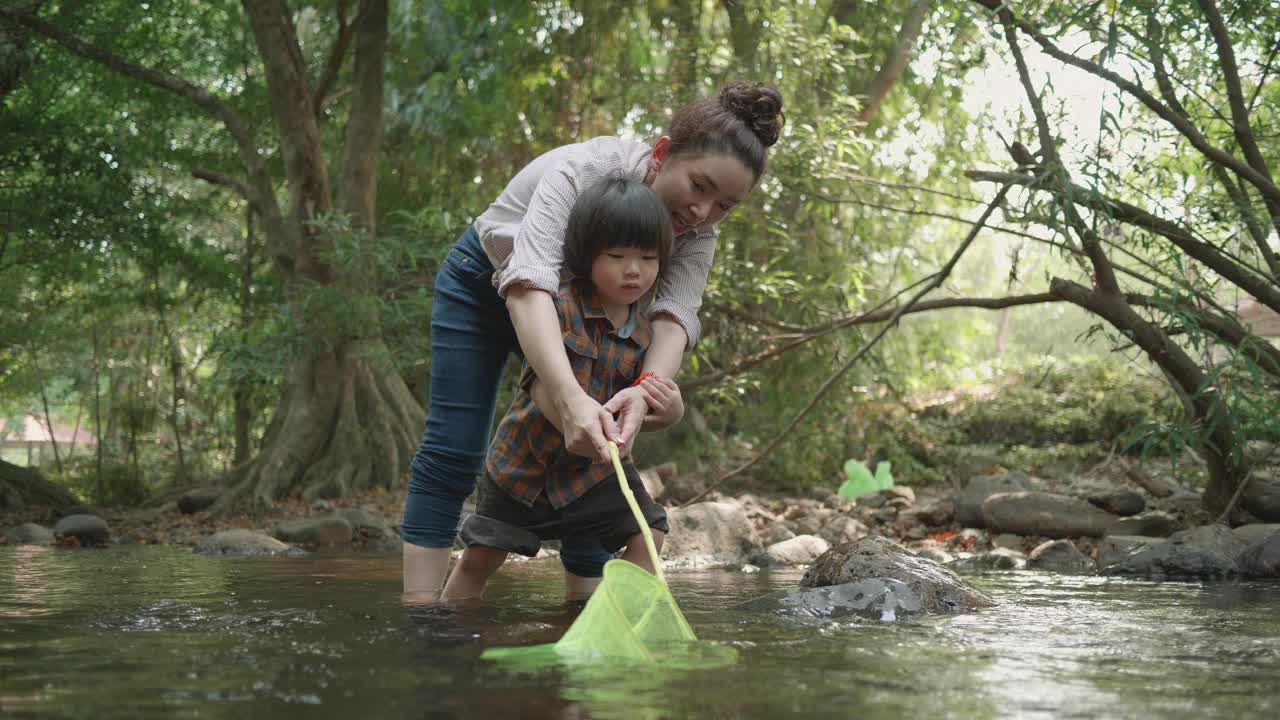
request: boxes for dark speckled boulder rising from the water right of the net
[800,536,995,612]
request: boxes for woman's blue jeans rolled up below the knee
[402,227,609,578]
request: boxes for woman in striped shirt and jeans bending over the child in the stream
[402,83,783,602]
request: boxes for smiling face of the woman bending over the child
[650,137,755,234]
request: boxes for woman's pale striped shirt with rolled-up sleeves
[475,137,716,350]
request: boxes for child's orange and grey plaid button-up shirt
[485,281,649,509]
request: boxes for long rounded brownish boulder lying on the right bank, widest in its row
[982,492,1116,538]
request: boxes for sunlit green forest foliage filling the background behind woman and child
[0,0,1280,515]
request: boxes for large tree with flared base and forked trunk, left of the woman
[0,0,424,507]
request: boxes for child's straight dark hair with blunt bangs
[564,178,675,278]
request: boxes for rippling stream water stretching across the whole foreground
[0,547,1280,720]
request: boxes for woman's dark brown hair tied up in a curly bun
[667,82,786,181]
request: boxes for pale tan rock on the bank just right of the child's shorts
[662,502,756,568]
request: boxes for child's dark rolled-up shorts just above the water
[462,464,669,557]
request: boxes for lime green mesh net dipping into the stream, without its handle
[481,560,737,667]
